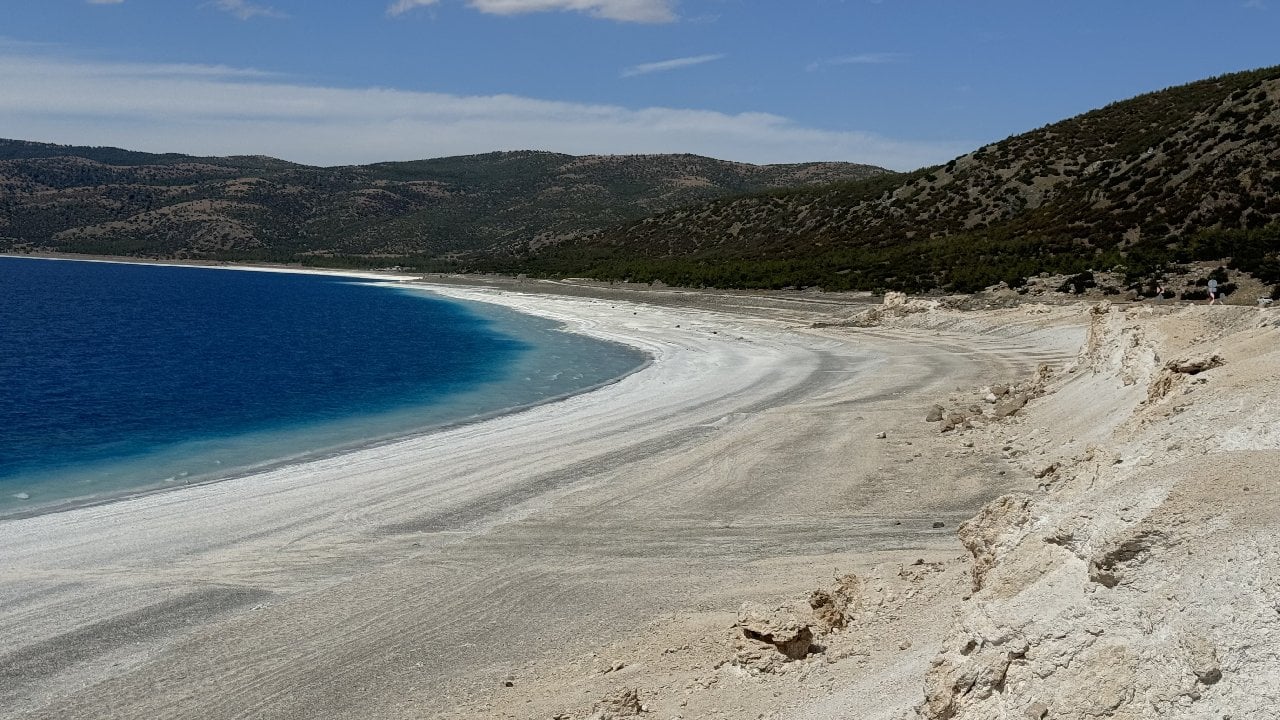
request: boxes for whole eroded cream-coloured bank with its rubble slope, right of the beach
[424,296,1280,720]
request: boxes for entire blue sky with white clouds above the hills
[0,0,1280,170]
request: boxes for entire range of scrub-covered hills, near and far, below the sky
[0,67,1280,295]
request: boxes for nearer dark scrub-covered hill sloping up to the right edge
[517,68,1280,291]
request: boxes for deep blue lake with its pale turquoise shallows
[0,258,643,514]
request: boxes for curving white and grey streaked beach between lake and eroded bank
[0,288,1070,719]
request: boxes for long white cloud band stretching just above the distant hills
[0,46,972,169]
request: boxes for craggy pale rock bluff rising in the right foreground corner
[913,305,1280,720]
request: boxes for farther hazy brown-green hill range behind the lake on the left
[0,140,884,264]
